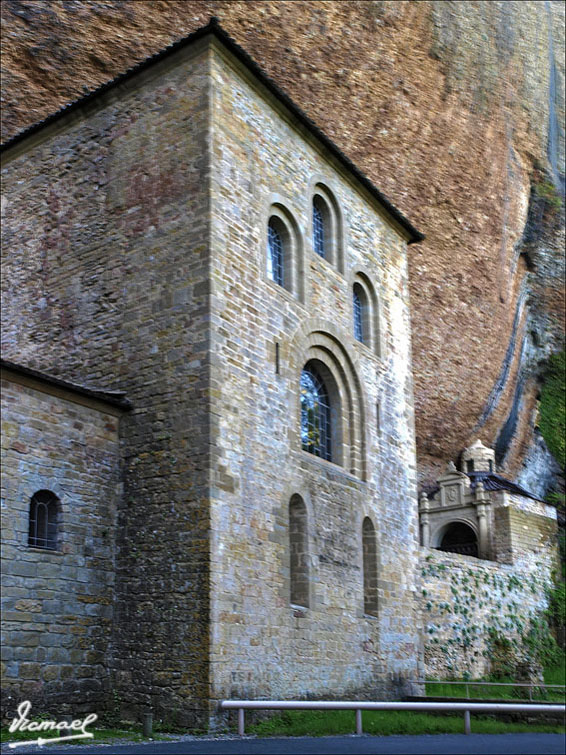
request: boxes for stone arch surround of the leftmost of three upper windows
[261,194,306,304]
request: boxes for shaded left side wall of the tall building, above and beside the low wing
[2,48,214,723]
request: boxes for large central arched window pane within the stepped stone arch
[301,362,332,461]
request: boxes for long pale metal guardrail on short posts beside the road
[220,700,566,737]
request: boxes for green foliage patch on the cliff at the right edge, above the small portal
[539,351,566,469]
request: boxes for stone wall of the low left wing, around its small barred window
[2,379,121,713]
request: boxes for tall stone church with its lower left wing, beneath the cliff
[2,16,560,726]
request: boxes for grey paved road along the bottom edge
[2,734,565,755]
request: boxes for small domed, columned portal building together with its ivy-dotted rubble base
[419,440,558,680]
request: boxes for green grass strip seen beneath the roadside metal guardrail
[251,710,564,737]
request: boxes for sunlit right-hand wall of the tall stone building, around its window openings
[207,45,419,699]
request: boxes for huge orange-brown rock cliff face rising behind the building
[2,0,565,492]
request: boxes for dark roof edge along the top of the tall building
[0,16,425,244]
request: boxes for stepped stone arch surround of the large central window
[286,319,367,480]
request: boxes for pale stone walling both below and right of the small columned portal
[420,496,557,679]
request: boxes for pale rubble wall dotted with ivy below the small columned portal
[420,548,556,679]
